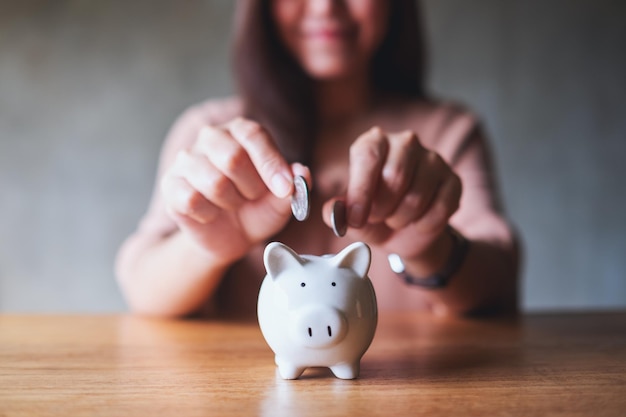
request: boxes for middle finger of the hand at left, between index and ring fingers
[194,126,266,200]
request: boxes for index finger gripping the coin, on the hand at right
[346,128,389,228]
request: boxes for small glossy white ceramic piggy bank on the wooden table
[257,242,378,379]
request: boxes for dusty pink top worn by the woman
[120,99,514,316]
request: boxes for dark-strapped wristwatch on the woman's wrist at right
[387,226,470,289]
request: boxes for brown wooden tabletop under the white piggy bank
[0,313,626,417]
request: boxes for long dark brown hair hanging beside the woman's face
[234,0,426,163]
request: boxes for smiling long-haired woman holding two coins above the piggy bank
[117,0,518,317]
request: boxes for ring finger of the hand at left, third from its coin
[174,151,244,210]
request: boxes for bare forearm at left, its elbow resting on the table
[116,232,229,317]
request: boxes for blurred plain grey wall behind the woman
[0,0,626,312]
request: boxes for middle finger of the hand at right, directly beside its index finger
[369,131,423,223]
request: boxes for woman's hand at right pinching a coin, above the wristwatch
[324,127,462,259]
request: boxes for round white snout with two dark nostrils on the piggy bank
[291,305,348,348]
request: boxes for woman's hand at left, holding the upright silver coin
[161,118,311,264]
